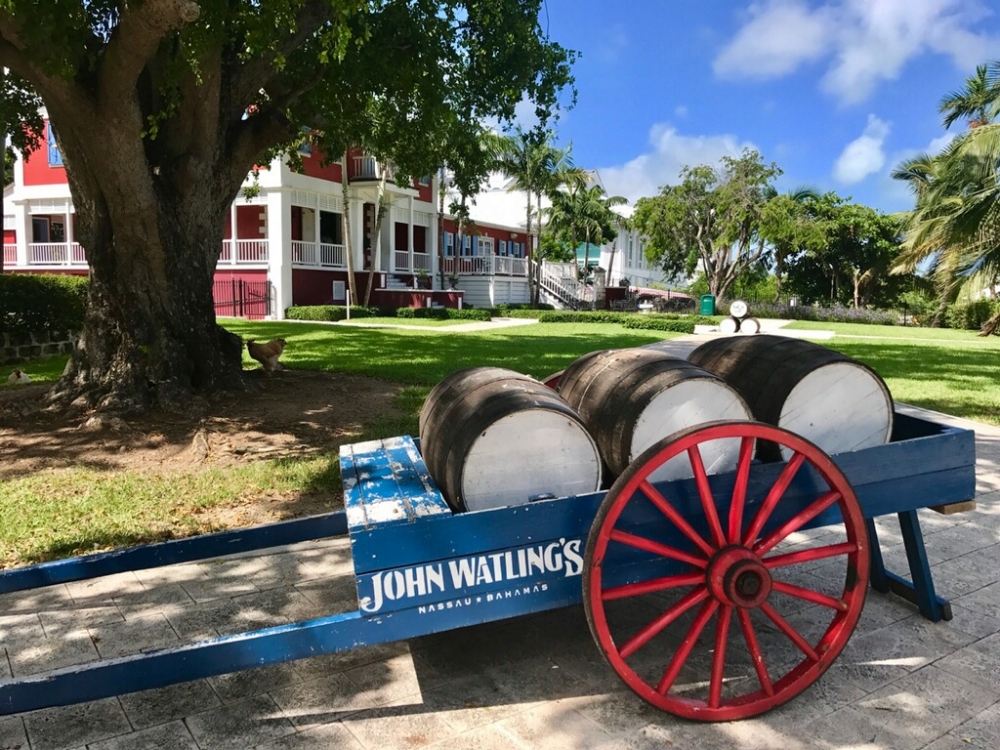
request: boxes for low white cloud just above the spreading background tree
[599,124,754,203]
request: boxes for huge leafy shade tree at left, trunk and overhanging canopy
[0,0,573,407]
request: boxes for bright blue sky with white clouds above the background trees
[468,0,1000,223]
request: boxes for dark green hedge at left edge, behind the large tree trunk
[0,273,87,338]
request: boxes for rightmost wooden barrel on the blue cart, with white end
[688,335,893,460]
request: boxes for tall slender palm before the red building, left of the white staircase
[486,128,585,304]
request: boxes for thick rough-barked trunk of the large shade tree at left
[43,81,254,411]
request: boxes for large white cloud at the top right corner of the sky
[714,0,1000,104]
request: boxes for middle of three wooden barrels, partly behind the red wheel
[559,348,750,480]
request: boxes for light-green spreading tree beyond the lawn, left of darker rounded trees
[633,149,782,297]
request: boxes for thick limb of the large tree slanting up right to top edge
[98,0,201,104]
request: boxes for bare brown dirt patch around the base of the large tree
[0,370,402,527]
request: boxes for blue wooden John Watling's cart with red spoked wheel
[0,414,975,720]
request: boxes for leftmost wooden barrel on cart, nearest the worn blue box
[420,367,601,511]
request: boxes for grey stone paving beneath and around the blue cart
[0,339,1000,750]
